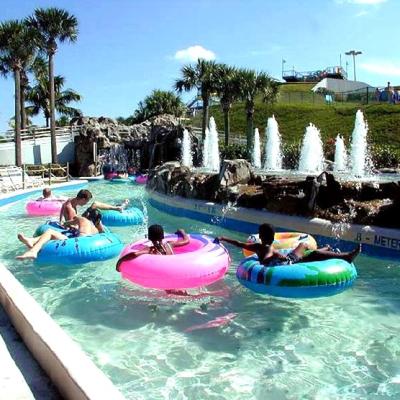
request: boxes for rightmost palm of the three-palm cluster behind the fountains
[238,69,278,155]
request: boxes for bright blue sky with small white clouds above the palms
[0,0,400,131]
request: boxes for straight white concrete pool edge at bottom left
[0,264,124,400]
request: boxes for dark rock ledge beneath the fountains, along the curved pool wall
[148,160,400,228]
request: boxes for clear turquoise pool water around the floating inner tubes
[0,183,400,400]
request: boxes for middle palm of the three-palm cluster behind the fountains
[216,64,240,146]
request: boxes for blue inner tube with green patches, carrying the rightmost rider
[236,256,357,298]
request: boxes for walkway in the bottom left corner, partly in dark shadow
[0,305,62,400]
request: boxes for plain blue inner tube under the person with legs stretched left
[35,222,123,265]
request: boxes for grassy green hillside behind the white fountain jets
[193,103,400,150]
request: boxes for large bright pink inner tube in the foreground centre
[120,234,230,290]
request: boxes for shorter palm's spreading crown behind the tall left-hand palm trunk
[26,73,82,127]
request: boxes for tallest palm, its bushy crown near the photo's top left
[27,7,78,163]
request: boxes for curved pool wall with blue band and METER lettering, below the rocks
[147,189,400,259]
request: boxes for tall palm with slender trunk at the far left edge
[0,20,36,166]
